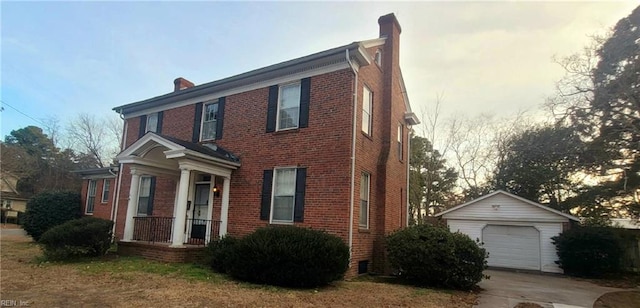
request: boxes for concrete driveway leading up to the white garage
[475,270,624,308]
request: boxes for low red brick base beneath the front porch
[118,242,205,263]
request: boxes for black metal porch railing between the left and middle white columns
[133,216,173,243]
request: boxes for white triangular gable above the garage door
[436,190,578,222]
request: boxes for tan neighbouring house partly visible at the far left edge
[0,172,28,223]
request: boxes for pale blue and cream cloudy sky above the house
[0,1,637,137]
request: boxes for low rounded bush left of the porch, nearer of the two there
[38,217,113,260]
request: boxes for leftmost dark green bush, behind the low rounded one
[24,192,82,241]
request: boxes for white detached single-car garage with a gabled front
[436,190,578,273]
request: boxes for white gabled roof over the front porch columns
[116,132,240,172]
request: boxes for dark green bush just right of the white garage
[551,227,623,277]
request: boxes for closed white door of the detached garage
[482,225,540,270]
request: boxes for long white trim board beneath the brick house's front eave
[125,62,349,119]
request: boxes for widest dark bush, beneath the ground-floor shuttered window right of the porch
[218,226,349,288]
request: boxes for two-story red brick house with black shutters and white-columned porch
[83,14,419,276]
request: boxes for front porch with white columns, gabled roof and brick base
[118,133,240,262]
